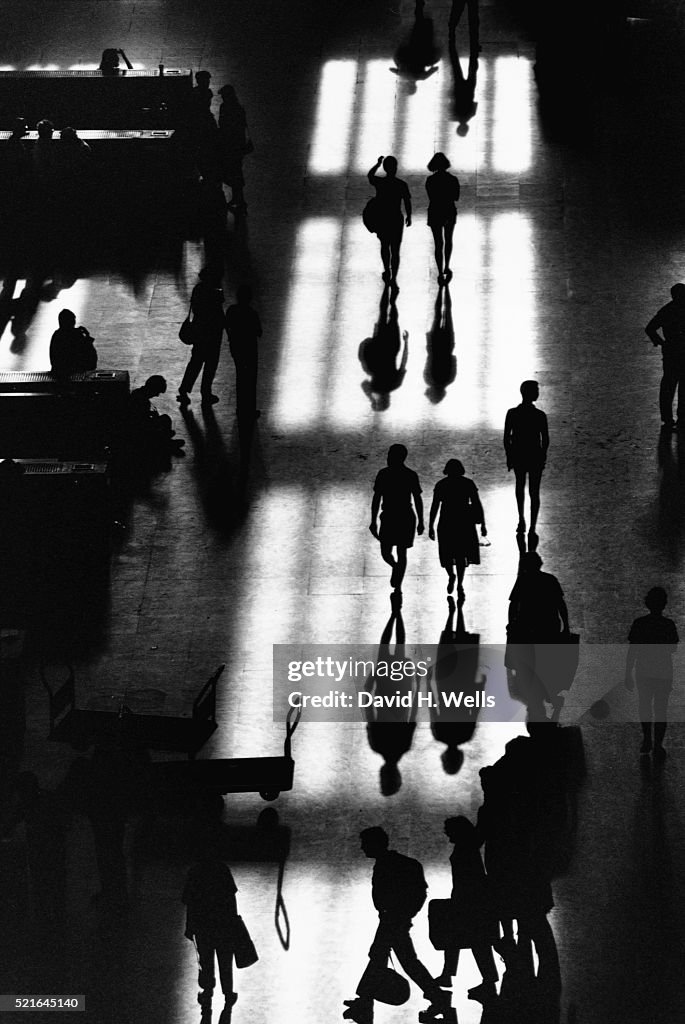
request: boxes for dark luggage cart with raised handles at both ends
[40,665,224,761]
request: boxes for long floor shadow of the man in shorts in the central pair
[365,591,416,797]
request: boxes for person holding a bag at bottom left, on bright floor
[182,841,238,1024]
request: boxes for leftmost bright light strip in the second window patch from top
[272,217,342,430]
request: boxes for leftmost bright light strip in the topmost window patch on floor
[309,60,357,174]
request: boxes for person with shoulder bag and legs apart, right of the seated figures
[176,266,223,407]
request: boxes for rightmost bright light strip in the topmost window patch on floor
[493,57,531,174]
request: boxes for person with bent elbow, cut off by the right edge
[645,284,685,430]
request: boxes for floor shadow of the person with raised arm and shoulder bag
[359,285,409,413]
